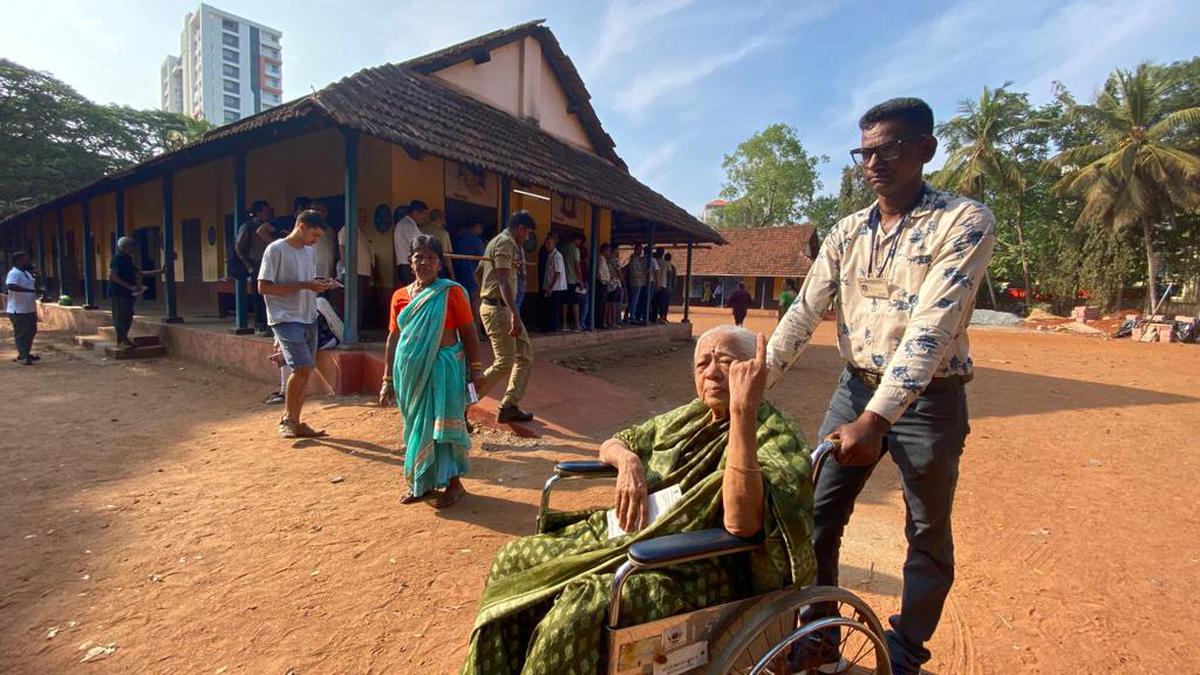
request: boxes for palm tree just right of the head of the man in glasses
[935,82,1033,304]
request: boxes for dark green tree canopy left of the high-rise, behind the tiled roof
[0,59,210,217]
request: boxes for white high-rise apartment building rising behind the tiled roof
[162,4,283,125]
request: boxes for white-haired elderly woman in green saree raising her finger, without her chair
[462,325,816,675]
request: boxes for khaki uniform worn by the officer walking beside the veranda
[479,229,533,407]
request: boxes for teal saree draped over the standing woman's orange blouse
[392,279,470,496]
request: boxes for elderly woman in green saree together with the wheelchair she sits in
[462,327,887,675]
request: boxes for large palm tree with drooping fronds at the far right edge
[1052,64,1200,309]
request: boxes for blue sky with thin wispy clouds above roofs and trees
[0,0,1200,213]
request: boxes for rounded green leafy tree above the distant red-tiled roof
[721,124,829,227]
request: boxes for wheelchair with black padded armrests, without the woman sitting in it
[538,441,892,675]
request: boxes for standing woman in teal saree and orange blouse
[379,234,484,508]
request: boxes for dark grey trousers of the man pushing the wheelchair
[812,371,971,669]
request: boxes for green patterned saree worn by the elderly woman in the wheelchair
[462,400,816,675]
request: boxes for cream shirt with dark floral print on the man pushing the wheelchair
[767,185,996,423]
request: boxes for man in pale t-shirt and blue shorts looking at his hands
[258,210,341,438]
